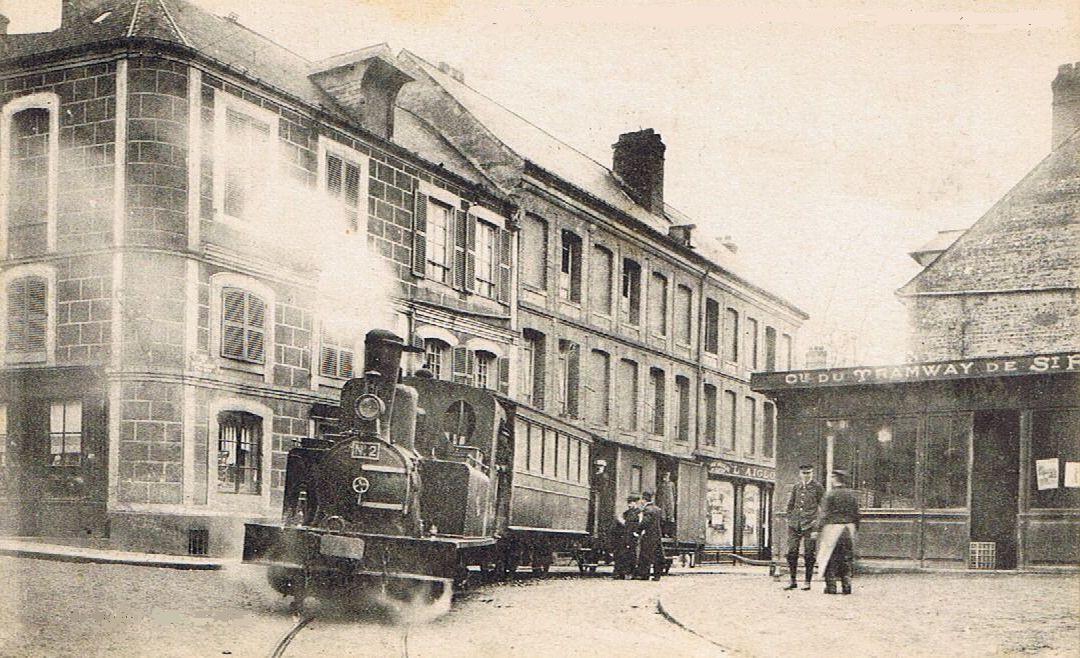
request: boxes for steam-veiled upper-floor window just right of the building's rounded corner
[222,108,271,217]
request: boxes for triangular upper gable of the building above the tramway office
[899,131,1080,296]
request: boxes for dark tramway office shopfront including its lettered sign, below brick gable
[752,353,1080,569]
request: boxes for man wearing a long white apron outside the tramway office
[818,471,861,594]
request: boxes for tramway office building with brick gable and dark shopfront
[754,65,1080,569]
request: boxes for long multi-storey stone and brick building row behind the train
[0,0,806,554]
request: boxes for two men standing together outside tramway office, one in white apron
[784,465,860,594]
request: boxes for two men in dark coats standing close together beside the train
[612,492,666,580]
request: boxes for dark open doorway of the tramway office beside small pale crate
[971,411,1020,569]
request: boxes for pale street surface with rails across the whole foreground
[0,558,1080,657]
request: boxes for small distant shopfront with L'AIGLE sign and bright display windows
[705,459,775,559]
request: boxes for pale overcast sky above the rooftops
[8,0,1080,363]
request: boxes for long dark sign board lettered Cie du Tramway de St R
[751,352,1080,390]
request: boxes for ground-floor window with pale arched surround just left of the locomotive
[217,412,262,494]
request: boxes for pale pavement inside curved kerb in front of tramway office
[659,572,1080,657]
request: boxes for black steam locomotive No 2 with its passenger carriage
[243,330,704,602]
